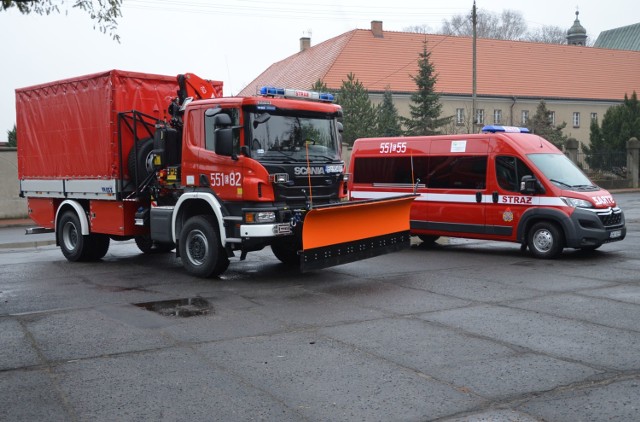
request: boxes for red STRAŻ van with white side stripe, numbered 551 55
[349,126,626,258]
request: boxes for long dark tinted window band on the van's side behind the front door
[353,155,487,189]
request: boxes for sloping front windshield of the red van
[528,154,599,190]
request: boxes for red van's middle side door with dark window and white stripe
[420,139,489,237]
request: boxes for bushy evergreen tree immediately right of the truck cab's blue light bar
[338,73,377,145]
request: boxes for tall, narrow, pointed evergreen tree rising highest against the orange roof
[404,41,451,135]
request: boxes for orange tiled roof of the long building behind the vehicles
[240,29,640,101]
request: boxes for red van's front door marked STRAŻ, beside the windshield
[487,155,534,240]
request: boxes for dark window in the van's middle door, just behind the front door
[426,156,487,189]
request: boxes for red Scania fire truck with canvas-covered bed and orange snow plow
[16,70,414,277]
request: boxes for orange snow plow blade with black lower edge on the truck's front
[300,195,416,272]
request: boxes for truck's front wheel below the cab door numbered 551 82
[179,215,229,277]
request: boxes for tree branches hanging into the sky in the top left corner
[0,0,122,42]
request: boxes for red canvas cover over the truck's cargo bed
[16,70,178,179]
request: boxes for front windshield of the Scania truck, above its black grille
[249,110,340,162]
